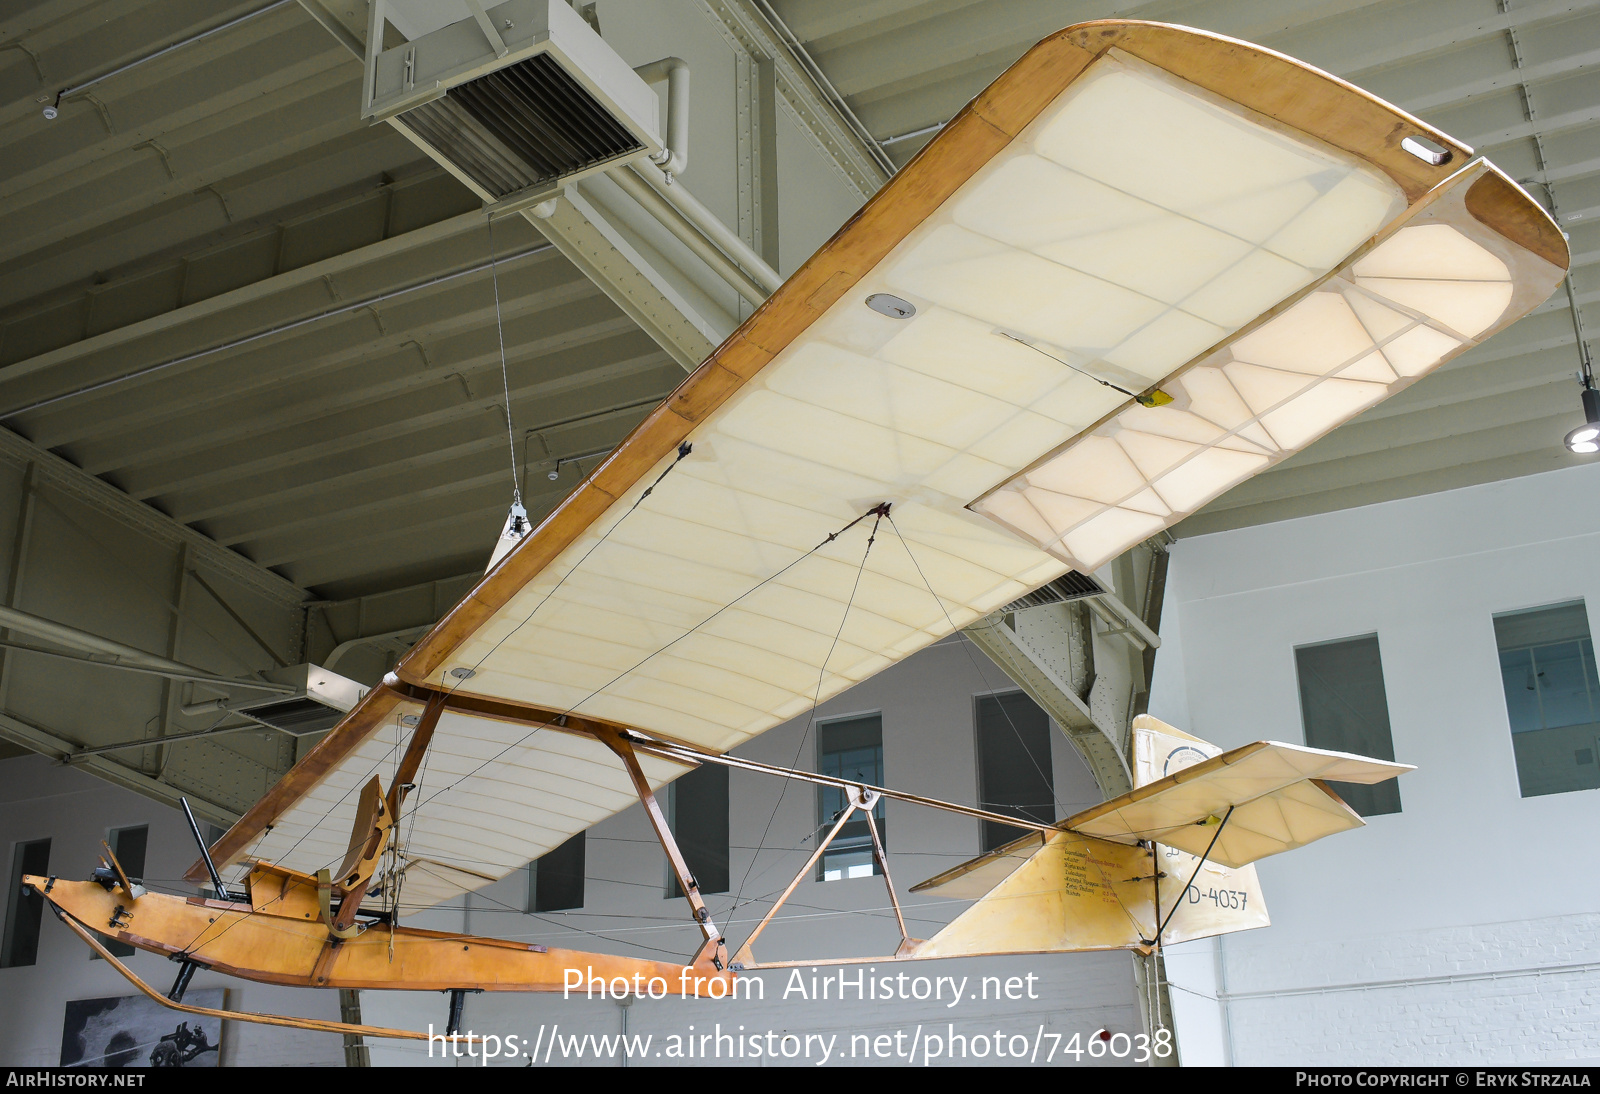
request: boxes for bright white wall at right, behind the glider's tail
[1150,465,1600,1064]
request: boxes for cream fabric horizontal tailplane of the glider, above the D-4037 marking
[1062,741,1413,867]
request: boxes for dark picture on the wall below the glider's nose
[61,988,222,1067]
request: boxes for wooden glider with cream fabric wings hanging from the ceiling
[40,21,1568,1036]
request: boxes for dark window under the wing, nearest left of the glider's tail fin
[978,691,1056,851]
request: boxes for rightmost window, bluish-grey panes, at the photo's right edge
[1494,600,1600,798]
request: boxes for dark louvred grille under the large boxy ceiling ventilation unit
[398,53,643,197]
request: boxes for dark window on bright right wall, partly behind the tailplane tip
[1294,635,1400,817]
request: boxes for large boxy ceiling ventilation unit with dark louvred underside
[362,0,661,203]
